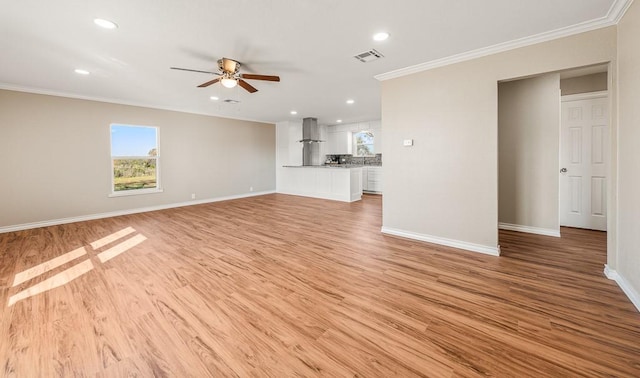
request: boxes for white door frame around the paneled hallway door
[558,90,613,232]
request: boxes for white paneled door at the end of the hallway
[560,93,609,231]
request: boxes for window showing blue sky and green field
[111,124,162,196]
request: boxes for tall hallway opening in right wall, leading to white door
[498,64,610,241]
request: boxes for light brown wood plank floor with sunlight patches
[0,195,640,377]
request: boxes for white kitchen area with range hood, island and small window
[276,118,382,202]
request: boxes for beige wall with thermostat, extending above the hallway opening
[382,27,616,252]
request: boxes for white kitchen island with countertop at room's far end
[278,165,362,202]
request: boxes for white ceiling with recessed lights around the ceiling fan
[0,0,627,124]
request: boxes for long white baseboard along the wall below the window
[0,190,275,234]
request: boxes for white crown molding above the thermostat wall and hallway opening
[374,0,633,81]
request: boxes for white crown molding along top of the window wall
[0,82,275,124]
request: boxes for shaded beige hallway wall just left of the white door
[498,73,560,236]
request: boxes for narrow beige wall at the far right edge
[608,1,640,309]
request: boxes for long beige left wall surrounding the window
[0,90,275,227]
